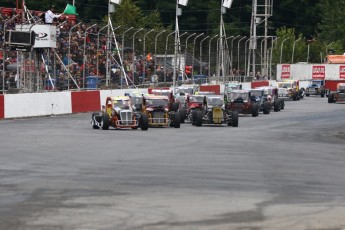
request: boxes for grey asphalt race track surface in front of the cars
[0,97,345,230]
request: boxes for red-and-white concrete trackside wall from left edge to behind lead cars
[0,89,147,119]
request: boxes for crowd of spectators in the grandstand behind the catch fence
[0,6,172,91]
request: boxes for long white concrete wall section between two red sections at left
[4,92,72,118]
